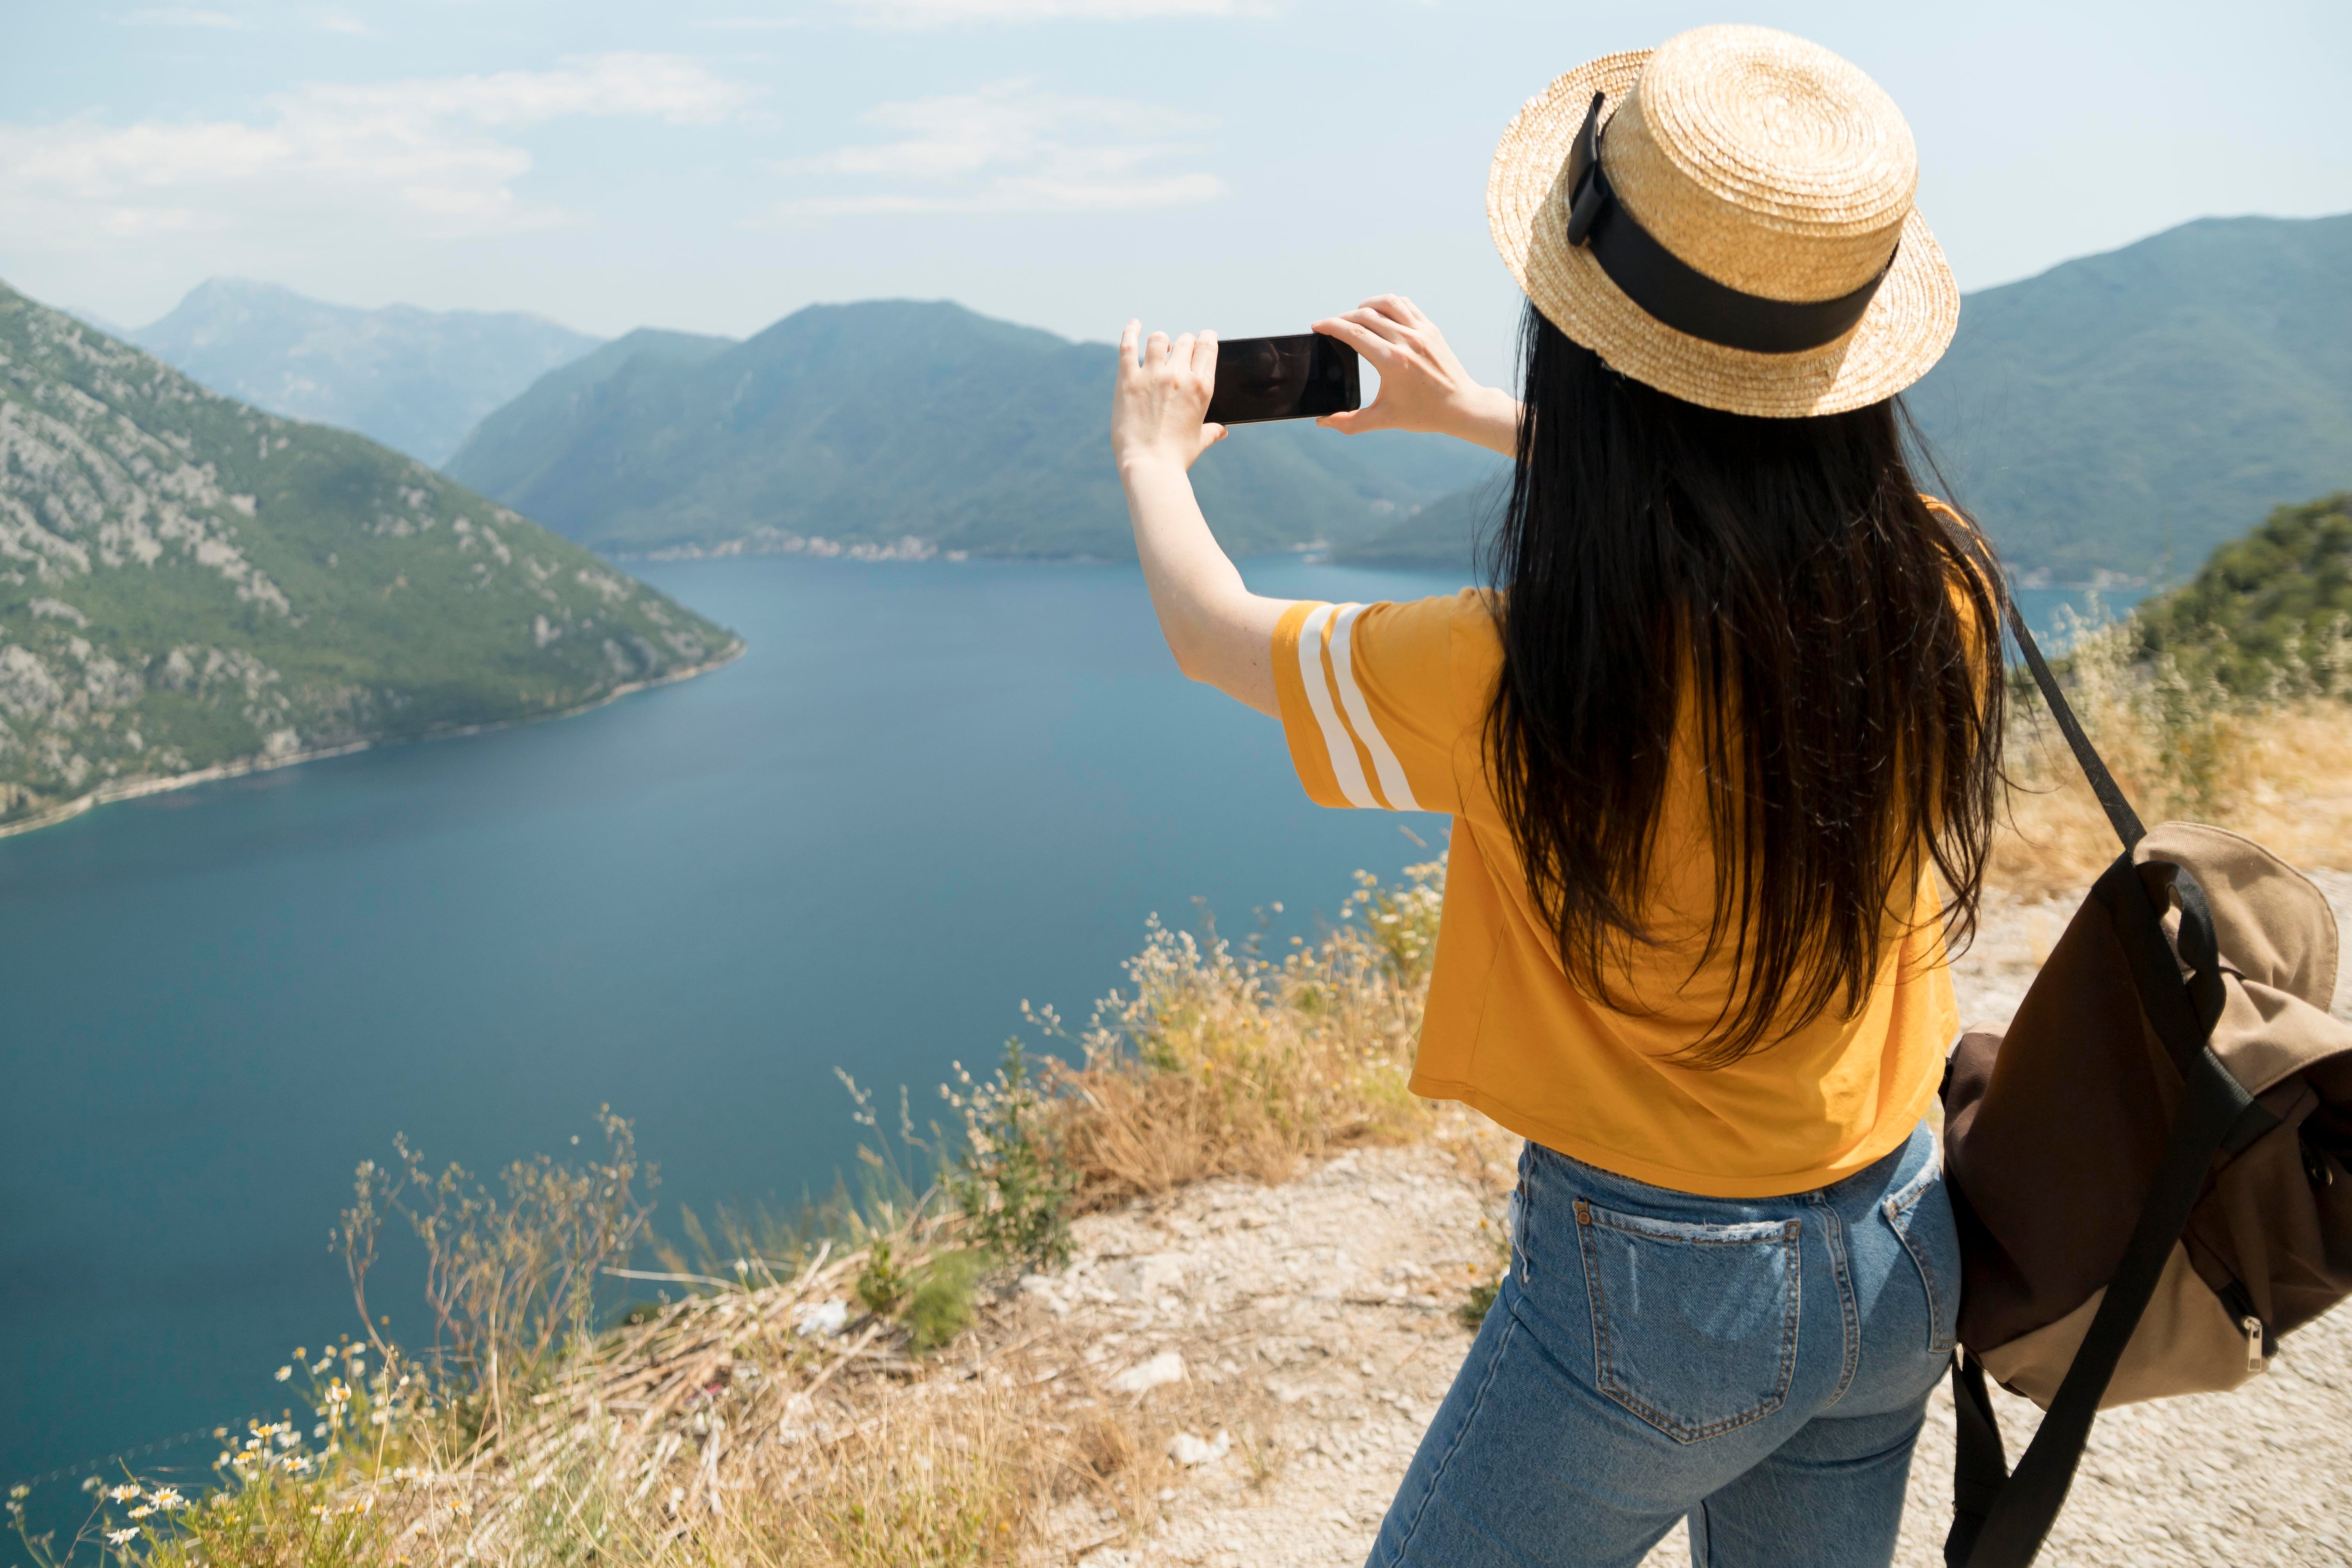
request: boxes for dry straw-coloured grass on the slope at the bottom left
[35,1253,1265,1568]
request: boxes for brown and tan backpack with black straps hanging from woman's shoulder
[1943,604,2352,1568]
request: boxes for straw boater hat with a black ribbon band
[1486,26,1959,419]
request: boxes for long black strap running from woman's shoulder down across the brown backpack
[1943,600,2263,1568]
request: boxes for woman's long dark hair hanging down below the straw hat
[1486,308,2004,1067]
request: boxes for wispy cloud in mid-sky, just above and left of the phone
[771,82,1225,221]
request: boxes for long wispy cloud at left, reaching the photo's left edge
[0,54,753,247]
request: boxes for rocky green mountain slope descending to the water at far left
[0,285,741,825]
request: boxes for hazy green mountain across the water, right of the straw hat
[1345,214,2352,581]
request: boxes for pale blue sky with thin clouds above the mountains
[0,0,2352,379]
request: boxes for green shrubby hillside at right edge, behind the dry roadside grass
[2138,494,2352,691]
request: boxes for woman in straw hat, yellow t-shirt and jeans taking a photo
[1112,28,2002,1568]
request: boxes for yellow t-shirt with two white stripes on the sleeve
[1275,590,1959,1196]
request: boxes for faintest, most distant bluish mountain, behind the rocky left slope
[127,277,597,468]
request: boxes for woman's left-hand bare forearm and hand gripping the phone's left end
[1110,322,1291,717]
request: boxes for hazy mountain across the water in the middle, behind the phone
[449,301,1496,557]
